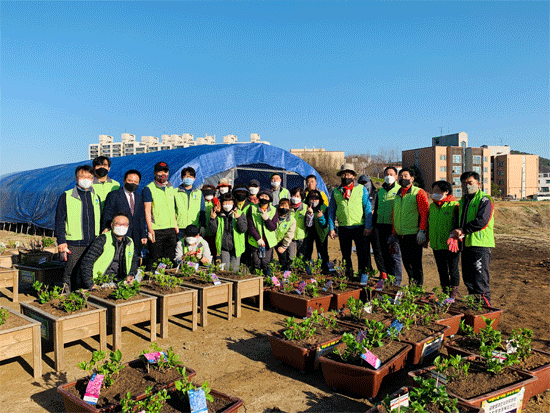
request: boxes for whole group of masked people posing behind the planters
[55,156,494,304]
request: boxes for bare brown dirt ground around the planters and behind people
[0,202,550,413]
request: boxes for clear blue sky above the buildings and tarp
[0,1,550,174]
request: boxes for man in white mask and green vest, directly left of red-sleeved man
[372,166,402,285]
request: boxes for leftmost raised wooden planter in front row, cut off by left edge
[0,307,42,379]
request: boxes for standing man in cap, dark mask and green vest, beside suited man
[141,162,179,270]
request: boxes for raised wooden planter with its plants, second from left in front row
[21,281,107,371]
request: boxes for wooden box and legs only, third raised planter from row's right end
[141,286,198,338]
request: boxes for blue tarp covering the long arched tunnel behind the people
[0,143,327,230]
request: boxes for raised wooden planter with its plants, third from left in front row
[89,274,157,350]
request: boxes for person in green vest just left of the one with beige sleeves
[246,191,279,274]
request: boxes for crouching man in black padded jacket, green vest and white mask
[81,212,138,289]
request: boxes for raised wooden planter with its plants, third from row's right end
[141,269,198,338]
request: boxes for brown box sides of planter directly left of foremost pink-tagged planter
[267,330,342,372]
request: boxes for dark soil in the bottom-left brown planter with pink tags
[67,362,181,408]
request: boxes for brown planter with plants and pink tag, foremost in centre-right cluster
[319,321,411,397]
